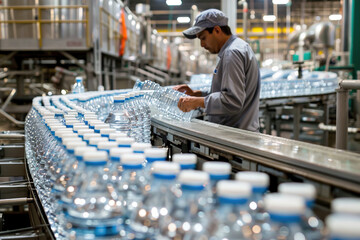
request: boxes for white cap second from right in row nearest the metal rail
[278,182,316,200]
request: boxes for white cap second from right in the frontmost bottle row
[264,193,305,215]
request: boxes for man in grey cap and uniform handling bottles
[174,9,260,132]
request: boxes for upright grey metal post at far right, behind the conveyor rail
[336,88,349,150]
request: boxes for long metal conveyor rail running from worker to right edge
[152,118,360,193]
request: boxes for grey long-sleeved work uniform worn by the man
[205,35,260,131]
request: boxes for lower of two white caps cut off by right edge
[325,213,360,239]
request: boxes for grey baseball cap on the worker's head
[183,8,229,39]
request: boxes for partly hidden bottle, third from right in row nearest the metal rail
[235,171,269,230]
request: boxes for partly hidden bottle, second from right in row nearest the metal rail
[278,182,324,240]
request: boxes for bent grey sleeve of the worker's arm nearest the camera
[205,50,246,115]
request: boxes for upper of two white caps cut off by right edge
[331,197,360,214]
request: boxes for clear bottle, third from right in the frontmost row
[210,180,253,240]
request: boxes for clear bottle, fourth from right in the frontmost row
[161,170,210,239]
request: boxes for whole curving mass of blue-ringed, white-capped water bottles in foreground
[25,91,360,239]
